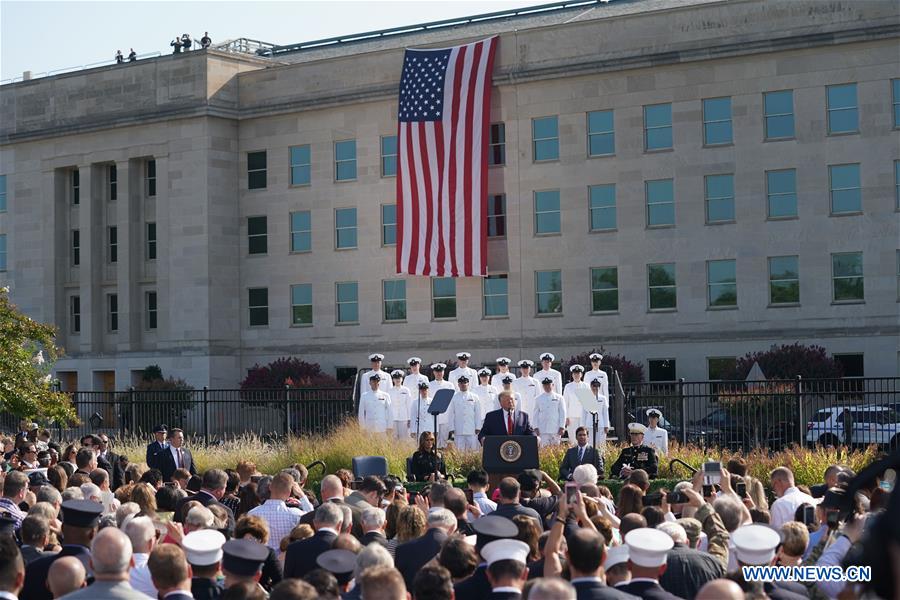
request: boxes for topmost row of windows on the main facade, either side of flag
[237,79,900,190]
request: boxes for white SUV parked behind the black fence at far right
[806,405,900,448]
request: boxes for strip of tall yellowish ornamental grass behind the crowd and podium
[114,422,877,485]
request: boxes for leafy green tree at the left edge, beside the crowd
[0,288,77,422]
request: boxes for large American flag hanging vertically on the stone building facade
[397,37,498,277]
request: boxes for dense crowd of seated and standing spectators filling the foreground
[0,412,900,600]
